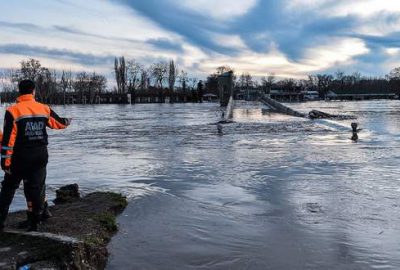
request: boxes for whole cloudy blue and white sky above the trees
[0,0,400,78]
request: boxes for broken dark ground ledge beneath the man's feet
[0,186,127,270]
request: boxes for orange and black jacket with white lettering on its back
[1,94,69,170]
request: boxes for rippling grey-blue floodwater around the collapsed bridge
[3,101,400,270]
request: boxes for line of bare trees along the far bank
[0,56,400,104]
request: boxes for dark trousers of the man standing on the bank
[0,148,48,223]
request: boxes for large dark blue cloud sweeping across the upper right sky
[114,0,399,69]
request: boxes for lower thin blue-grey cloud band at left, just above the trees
[0,44,114,66]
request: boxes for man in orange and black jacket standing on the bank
[0,80,70,231]
